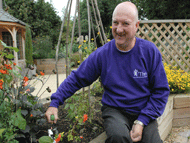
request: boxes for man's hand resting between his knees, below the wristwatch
[130,124,143,142]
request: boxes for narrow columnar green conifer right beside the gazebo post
[25,26,33,66]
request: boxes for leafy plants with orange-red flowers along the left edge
[0,41,52,143]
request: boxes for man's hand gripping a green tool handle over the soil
[45,107,58,124]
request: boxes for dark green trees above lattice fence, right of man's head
[132,0,190,20]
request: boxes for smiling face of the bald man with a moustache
[112,3,139,50]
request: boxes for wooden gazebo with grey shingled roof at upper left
[0,0,26,68]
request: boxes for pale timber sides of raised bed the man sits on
[90,94,190,143]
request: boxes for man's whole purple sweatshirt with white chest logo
[50,38,169,125]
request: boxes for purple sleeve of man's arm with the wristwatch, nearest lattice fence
[138,48,170,125]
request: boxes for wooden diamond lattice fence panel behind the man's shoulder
[136,20,190,72]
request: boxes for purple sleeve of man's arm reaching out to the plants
[50,51,100,108]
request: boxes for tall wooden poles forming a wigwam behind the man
[55,0,107,88]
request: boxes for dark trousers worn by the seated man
[101,106,163,143]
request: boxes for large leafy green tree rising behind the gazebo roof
[4,0,61,48]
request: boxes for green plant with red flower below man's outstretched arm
[64,82,101,142]
